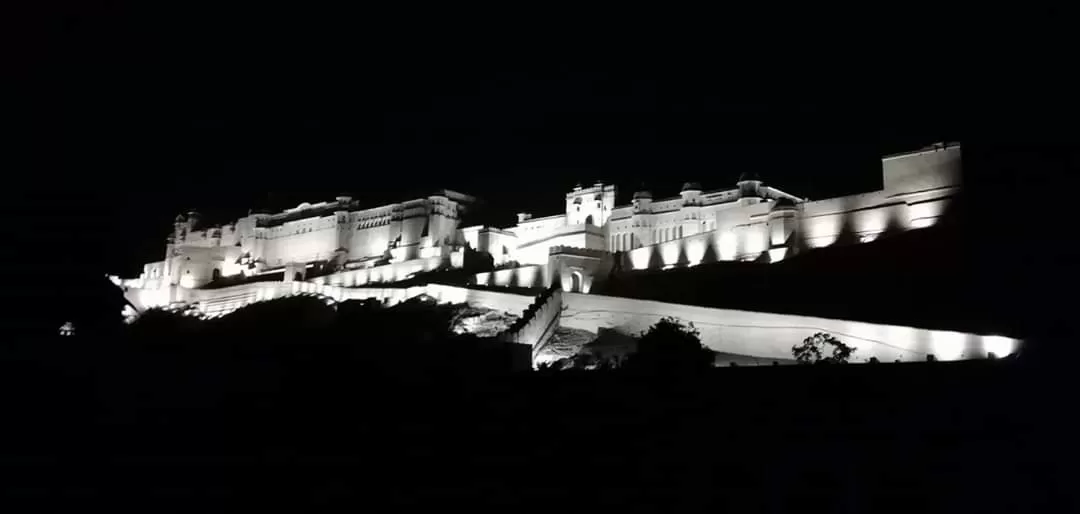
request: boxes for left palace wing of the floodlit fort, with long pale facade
[113,190,474,309]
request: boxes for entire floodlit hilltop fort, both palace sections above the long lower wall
[112,144,1010,359]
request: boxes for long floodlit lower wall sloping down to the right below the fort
[118,268,1022,362]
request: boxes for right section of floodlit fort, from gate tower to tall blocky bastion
[467,144,961,293]
